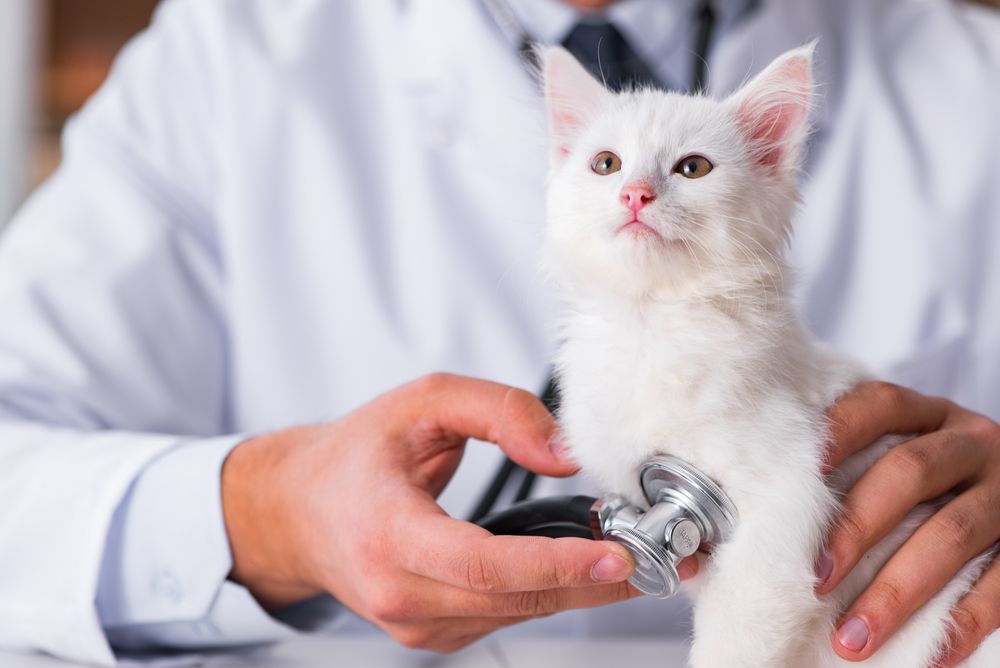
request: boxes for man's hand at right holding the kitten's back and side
[816,383,1000,666]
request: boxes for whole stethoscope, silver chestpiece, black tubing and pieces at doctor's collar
[469,0,737,598]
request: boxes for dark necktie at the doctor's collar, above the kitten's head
[563,23,660,91]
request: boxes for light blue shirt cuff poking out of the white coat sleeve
[96,436,339,649]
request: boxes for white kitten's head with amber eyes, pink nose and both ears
[541,45,813,296]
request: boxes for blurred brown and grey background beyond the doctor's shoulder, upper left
[0,0,1000,228]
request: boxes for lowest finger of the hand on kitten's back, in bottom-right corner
[935,561,1000,668]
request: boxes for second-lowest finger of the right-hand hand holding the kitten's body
[834,491,998,661]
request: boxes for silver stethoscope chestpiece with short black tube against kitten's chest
[480,455,737,598]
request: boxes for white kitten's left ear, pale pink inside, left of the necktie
[537,46,611,161]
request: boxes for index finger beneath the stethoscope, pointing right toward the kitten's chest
[398,513,634,593]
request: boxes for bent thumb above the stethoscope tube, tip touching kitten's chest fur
[394,374,578,476]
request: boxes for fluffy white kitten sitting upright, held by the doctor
[542,46,1000,668]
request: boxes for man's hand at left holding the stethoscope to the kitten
[222,374,680,651]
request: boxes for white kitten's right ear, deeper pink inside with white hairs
[727,41,816,171]
